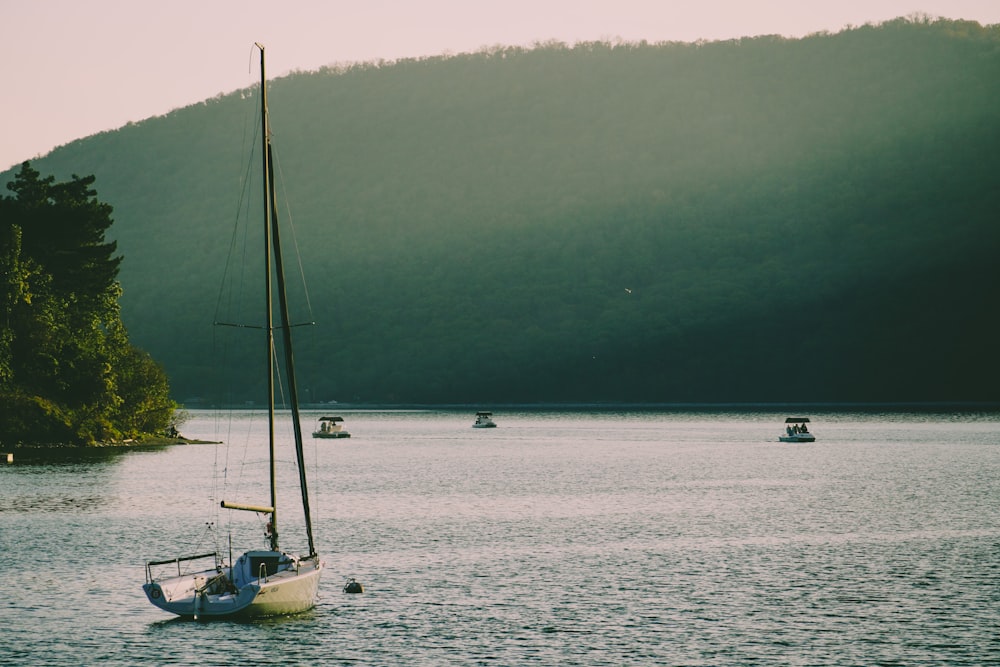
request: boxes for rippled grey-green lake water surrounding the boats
[0,411,1000,667]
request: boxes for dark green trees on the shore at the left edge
[0,163,176,445]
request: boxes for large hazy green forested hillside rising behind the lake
[5,17,1000,405]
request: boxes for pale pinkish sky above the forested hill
[0,0,1000,170]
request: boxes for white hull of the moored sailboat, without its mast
[142,557,323,620]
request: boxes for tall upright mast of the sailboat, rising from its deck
[257,43,278,551]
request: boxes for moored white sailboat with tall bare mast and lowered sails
[142,44,323,619]
